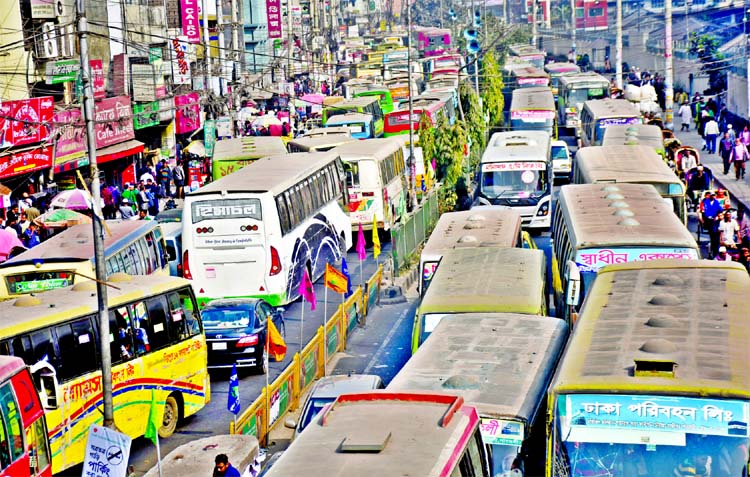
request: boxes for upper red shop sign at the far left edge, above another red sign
[0,96,54,147]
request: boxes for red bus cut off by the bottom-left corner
[0,356,52,477]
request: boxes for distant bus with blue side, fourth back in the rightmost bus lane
[579,98,641,147]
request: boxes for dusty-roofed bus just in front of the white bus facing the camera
[418,209,536,296]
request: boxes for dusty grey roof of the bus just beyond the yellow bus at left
[0,220,159,270]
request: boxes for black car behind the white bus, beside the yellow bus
[201,298,286,374]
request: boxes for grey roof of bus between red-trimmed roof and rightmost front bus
[388,313,568,423]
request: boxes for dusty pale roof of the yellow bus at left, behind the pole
[0,273,190,339]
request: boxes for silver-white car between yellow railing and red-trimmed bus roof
[284,374,385,440]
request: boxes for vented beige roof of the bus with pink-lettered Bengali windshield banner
[556,182,698,249]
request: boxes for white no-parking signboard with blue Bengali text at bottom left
[82,425,131,477]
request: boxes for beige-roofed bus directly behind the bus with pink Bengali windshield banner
[573,146,688,225]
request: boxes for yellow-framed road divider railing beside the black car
[229,265,383,446]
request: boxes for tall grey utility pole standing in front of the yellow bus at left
[76,0,115,429]
